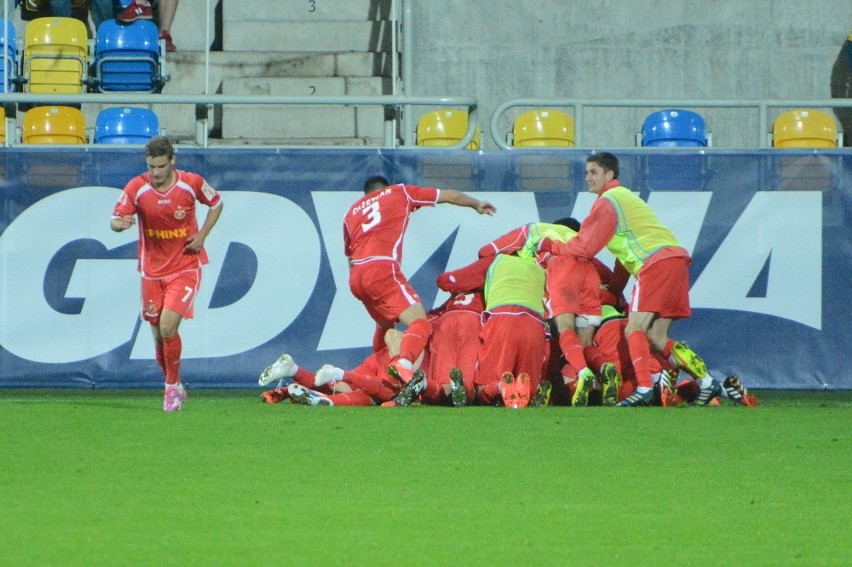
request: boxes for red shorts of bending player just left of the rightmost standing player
[547,256,601,317]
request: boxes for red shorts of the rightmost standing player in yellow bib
[630,257,692,319]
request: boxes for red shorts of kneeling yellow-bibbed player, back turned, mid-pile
[474,306,547,391]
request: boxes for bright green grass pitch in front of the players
[0,389,852,566]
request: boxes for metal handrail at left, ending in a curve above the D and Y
[0,93,479,149]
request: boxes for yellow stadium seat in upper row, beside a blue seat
[22,18,89,94]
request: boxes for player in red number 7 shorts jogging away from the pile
[110,136,222,411]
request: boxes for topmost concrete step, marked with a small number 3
[222,0,391,21]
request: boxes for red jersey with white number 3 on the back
[343,183,441,264]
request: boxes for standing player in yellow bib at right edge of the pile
[539,152,722,406]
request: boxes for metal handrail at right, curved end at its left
[489,98,852,150]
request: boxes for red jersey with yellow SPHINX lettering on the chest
[112,169,222,279]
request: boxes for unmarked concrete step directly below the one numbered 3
[222,20,391,53]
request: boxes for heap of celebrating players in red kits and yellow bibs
[259,152,758,408]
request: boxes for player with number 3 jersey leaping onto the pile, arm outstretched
[343,176,497,383]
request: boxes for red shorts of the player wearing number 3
[349,260,420,327]
